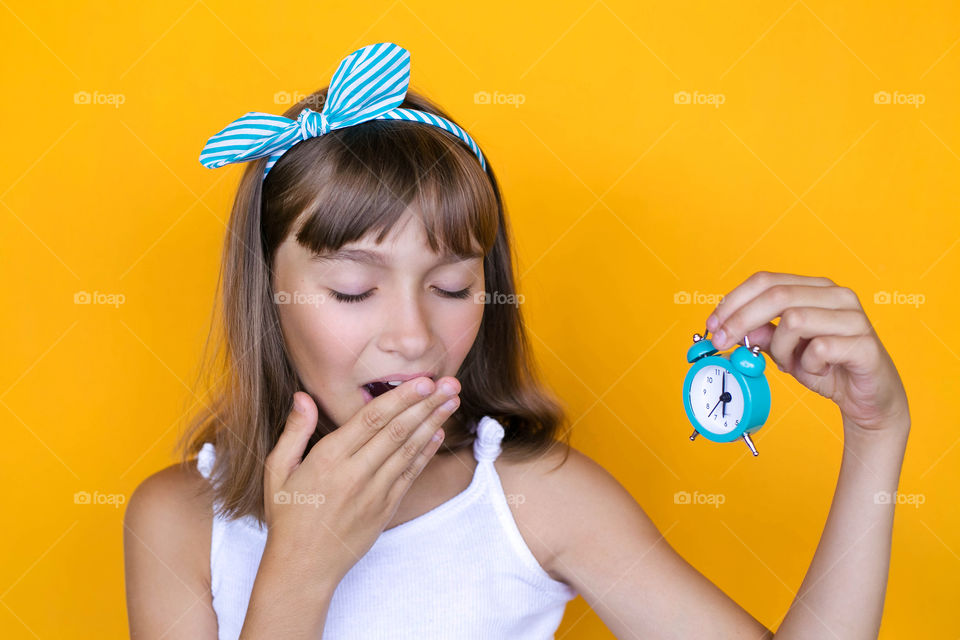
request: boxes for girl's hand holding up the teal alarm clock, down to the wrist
[707,271,910,430]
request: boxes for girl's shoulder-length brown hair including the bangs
[177,88,569,522]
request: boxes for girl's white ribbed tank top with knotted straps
[197,416,577,640]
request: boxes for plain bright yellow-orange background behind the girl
[0,0,960,639]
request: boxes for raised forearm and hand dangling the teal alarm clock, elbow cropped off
[707,272,910,640]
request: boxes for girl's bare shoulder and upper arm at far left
[123,464,217,638]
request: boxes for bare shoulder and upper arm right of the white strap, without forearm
[497,443,773,638]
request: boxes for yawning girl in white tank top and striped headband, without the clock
[124,43,910,640]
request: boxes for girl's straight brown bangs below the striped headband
[264,120,499,255]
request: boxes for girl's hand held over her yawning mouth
[263,377,460,582]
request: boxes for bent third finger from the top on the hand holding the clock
[761,307,870,372]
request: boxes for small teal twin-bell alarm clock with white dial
[683,331,770,455]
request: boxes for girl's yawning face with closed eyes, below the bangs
[274,209,485,426]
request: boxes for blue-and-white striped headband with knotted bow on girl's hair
[200,42,487,178]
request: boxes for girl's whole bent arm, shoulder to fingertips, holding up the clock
[540,272,910,640]
